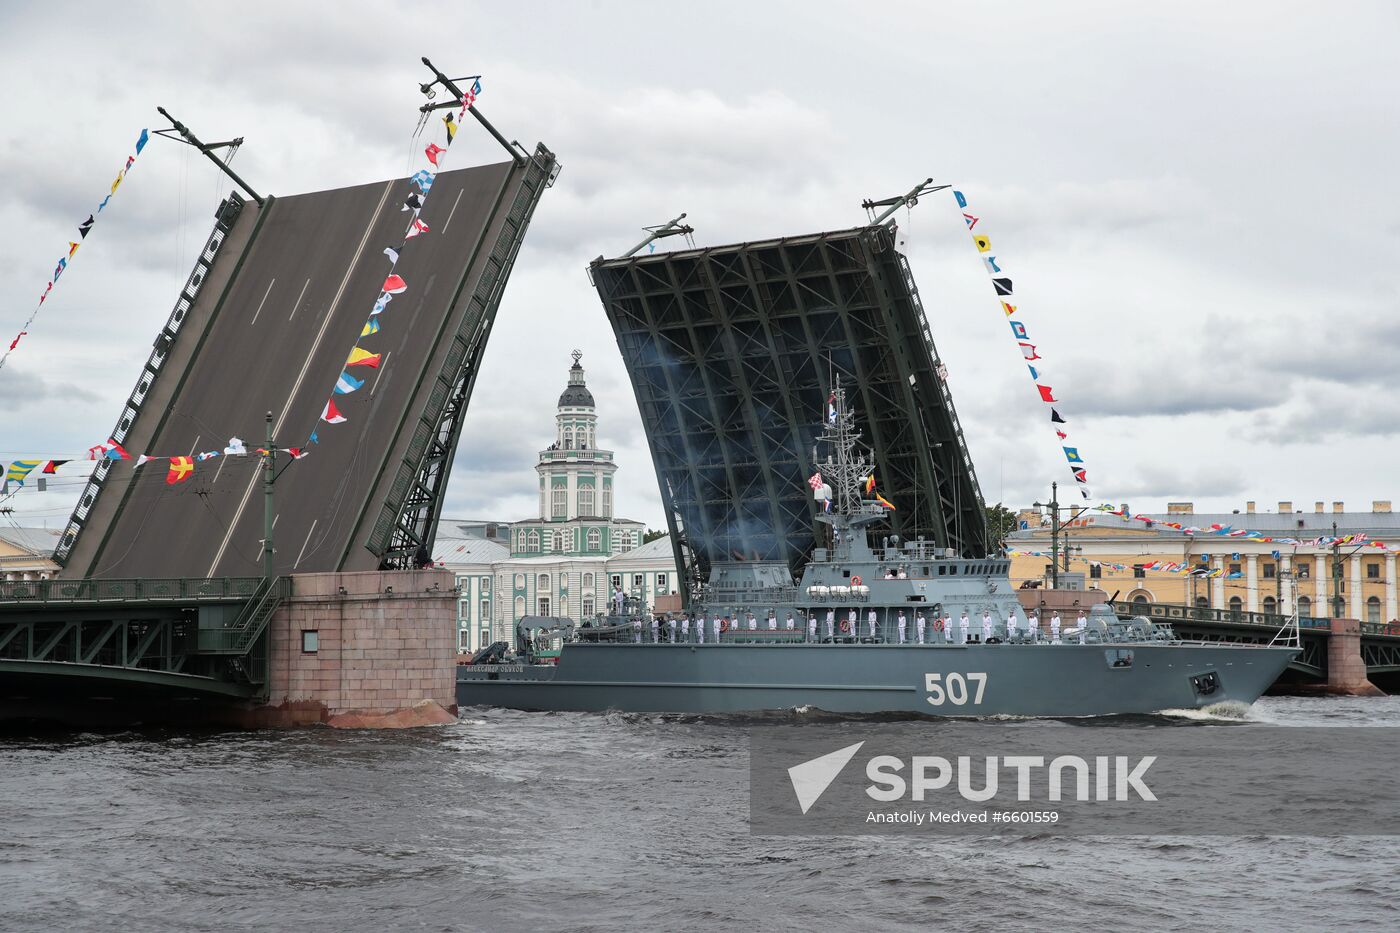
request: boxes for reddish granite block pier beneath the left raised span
[241,570,456,728]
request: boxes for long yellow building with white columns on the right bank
[1007,500,1400,622]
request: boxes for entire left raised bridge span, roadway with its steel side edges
[56,146,559,579]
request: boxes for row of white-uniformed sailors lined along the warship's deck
[631,609,1088,644]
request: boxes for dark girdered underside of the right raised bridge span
[591,226,987,584]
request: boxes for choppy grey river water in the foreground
[0,698,1400,932]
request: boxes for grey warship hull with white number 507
[456,643,1296,717]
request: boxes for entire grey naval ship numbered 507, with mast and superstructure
[456,384,1298,717]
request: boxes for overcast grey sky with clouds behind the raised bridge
[0,0,1400,527]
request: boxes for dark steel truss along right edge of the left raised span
[365,144,559,570]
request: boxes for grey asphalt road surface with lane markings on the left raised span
[63,163,521,577]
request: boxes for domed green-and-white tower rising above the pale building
[511,350,640,556]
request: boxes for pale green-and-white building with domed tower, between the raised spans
[433,352,680,651]
